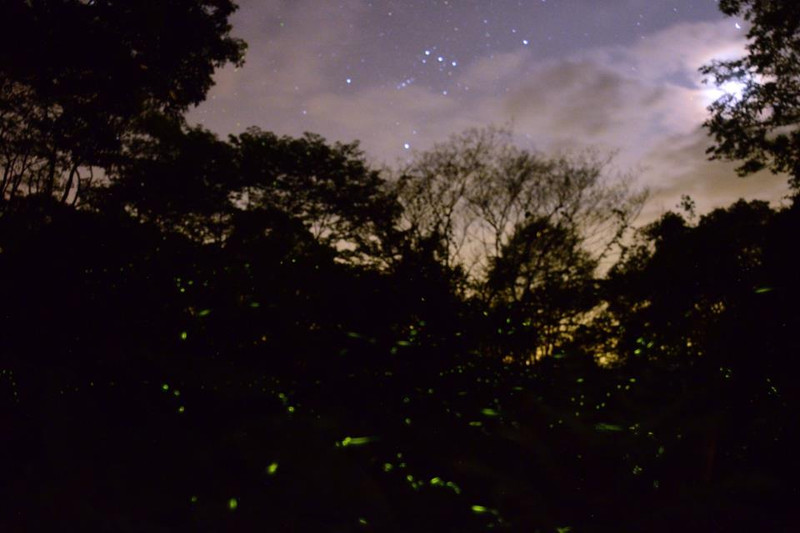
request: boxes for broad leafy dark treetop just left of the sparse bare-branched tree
[100,116,399,265]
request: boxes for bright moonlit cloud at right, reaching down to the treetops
[494,21,789,221]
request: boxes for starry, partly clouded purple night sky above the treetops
[189,0,788,221]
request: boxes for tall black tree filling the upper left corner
[0,0,245,208]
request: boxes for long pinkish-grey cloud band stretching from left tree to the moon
[190,9,786,215]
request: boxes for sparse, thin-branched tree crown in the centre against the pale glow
[397,128,644,289]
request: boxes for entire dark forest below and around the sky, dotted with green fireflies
[0,0,800,533]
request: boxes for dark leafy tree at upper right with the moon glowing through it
[701,0,800,189]
